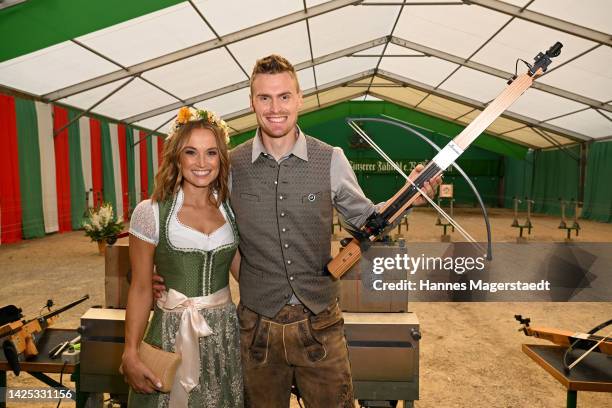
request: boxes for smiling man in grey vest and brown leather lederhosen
[155,55,440,408]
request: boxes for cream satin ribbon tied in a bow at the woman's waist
[157,286,232,408]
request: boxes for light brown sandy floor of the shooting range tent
[0,212,612,408]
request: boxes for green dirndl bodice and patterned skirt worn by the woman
[128,194,244,408]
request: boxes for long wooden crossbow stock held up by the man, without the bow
[326,42,563,279]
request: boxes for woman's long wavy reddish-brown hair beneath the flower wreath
[151,120,230,206]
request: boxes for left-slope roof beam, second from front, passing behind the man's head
[123,36,388,123]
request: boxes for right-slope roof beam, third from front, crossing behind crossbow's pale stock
[376,70,593,142]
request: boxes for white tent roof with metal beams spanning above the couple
[0,0,612,148]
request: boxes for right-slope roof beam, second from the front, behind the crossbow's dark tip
[391,36,612,112]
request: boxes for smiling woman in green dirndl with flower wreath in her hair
[122,108,243,408]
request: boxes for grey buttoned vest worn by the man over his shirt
[231,136,339,318]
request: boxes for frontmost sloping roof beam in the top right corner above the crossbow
[466,0,612,46]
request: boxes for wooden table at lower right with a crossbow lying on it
[522,344,612,408]
